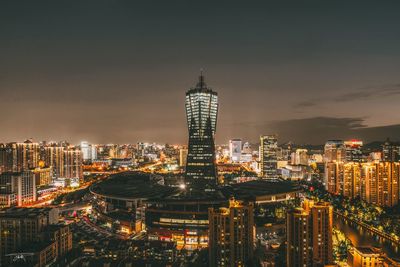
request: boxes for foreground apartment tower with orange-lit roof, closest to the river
[286,199,333,267]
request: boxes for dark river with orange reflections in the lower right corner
[333,215,400,258]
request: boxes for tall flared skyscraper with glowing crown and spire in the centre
[186,74,218,189]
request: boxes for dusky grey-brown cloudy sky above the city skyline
[0,0,400,144]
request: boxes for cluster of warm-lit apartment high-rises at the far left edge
[0,140,83,207]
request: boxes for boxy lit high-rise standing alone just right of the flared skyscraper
[260,135,278,179]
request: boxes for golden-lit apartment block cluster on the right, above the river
[324,140,400,207]
